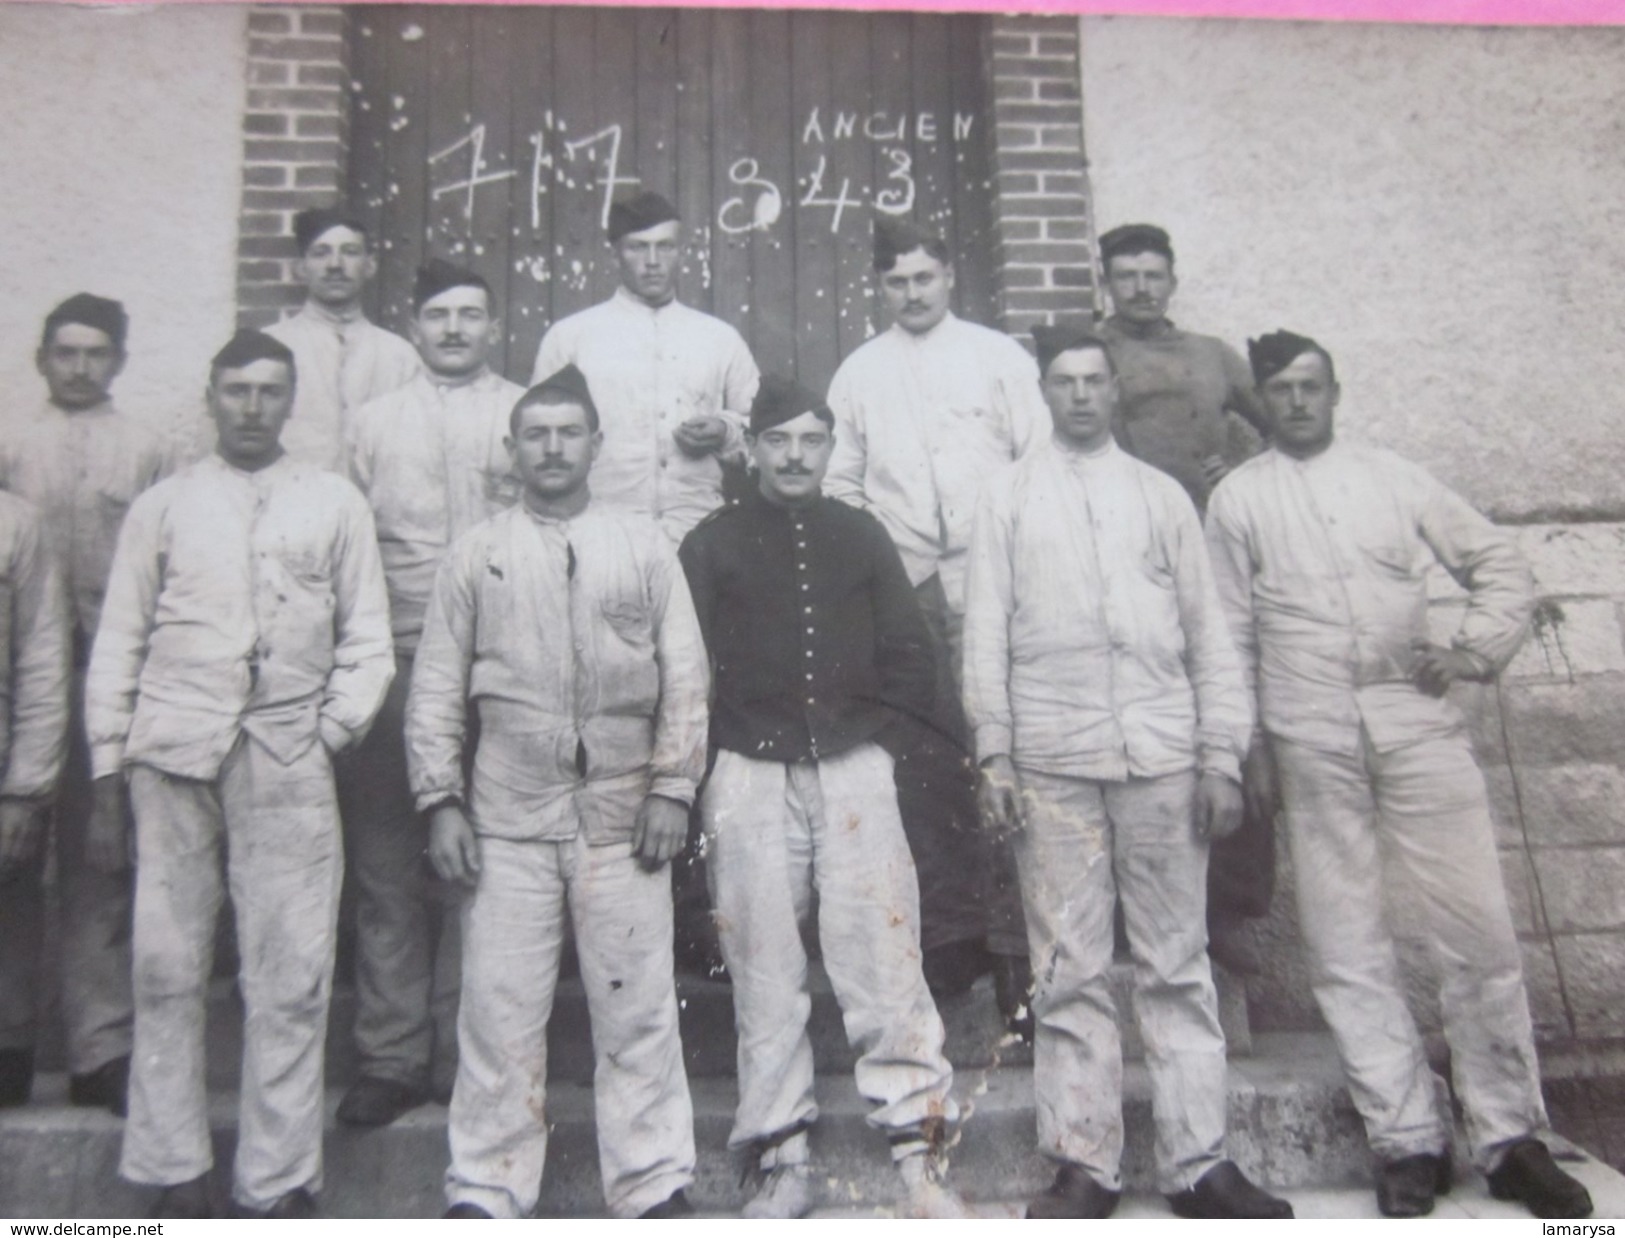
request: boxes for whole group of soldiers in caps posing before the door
[0,193,1591,1219]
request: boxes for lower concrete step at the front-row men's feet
[0,1033,1534,1217]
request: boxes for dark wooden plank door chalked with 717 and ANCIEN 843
[349,5,995,388]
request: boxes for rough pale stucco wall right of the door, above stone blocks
[1081,18,1625,518]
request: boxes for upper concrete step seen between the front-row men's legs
[199,963,1251,1089]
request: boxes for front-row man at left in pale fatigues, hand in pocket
[85,331,395,1217]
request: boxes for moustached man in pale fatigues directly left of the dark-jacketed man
[406,366,709,1219]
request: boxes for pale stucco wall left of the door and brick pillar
[0,3,247,438]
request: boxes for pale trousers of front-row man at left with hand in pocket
[119,736,345,1209]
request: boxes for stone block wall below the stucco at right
[1250,523,1625,1045]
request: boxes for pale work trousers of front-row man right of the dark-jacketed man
[1016,770,1225,1194]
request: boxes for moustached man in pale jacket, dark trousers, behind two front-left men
[338,258,525,1126]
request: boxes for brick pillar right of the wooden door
[991,16,1097,333]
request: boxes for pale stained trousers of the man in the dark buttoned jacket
[700,744,957,1158]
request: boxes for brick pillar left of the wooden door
[237,5,349,327]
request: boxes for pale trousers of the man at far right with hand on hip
[1272,734,1545,1171]
